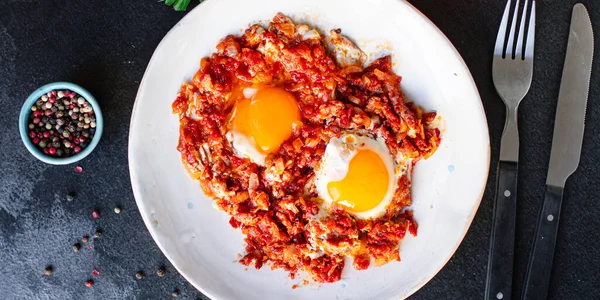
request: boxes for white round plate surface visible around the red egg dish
[129,0,490,300]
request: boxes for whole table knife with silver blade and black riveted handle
[523,3,594,300]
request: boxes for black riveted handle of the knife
[523,185,563,300]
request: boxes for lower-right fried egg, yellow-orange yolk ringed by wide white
[315,134,397,219]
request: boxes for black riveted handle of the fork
[485,161,518,300]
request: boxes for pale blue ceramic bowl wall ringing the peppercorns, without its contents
[19,82,104,165]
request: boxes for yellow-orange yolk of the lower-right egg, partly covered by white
[327,150,390,212]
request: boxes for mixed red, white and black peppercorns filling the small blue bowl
[27,90,96,157]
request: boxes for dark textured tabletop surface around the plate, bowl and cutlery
[0,0,600,299]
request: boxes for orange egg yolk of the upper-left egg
[234,87,301,153]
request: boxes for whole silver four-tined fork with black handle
[485,0,535,300]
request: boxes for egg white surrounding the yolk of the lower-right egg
[315,134,402,219]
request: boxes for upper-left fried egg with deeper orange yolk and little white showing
[227,86,302,166]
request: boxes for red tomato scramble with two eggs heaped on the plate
[173,14,441,282]
